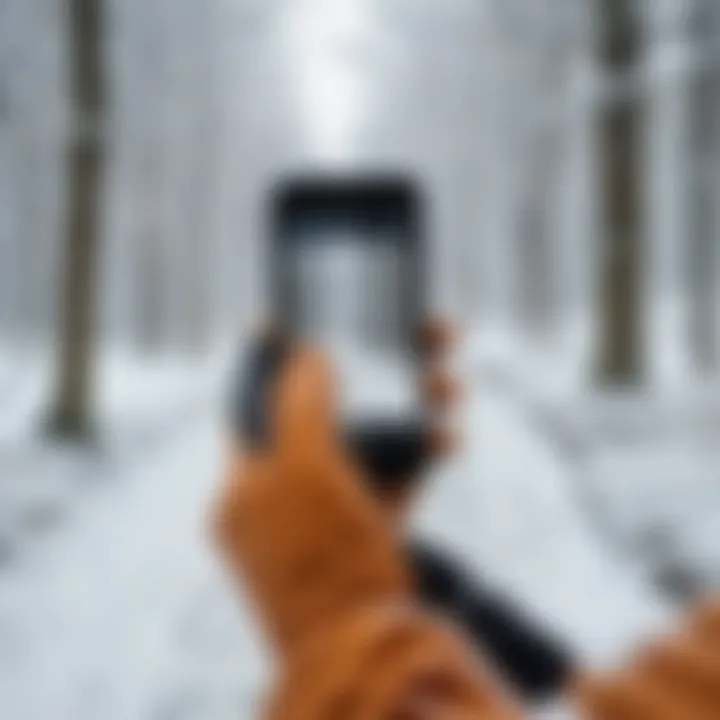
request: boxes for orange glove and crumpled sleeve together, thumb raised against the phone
[215,352,520,720]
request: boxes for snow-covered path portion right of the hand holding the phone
[410,380,672,665]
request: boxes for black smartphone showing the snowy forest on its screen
[270,176,426,476]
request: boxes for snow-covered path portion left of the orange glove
[0,404,268,720]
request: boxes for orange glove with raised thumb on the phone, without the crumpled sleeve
[215,353,409,652]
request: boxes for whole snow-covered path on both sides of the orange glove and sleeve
[0,380,680,720]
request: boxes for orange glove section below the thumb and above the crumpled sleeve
[212,450,410,654]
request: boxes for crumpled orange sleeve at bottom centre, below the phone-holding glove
[267,603,522,720]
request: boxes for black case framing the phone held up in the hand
[233,176,428,485]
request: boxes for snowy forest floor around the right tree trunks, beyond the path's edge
[464,304,720,595]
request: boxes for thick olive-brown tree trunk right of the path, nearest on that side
[598,0,643,385]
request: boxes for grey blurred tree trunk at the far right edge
[688,0,720,374]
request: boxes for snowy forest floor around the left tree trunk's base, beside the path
[0,347,228,557]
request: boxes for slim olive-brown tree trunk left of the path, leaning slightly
[49,0,104,440]
